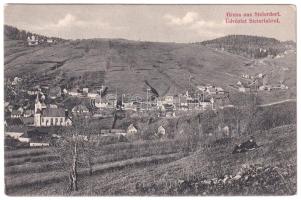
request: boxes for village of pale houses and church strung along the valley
[5,65,288,147]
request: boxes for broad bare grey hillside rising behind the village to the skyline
[4,26,296,99]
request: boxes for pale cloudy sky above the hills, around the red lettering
[4,4,296,43]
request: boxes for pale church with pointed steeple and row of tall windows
[34,94,72,127]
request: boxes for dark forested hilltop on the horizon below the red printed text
[200,35,294,58]
